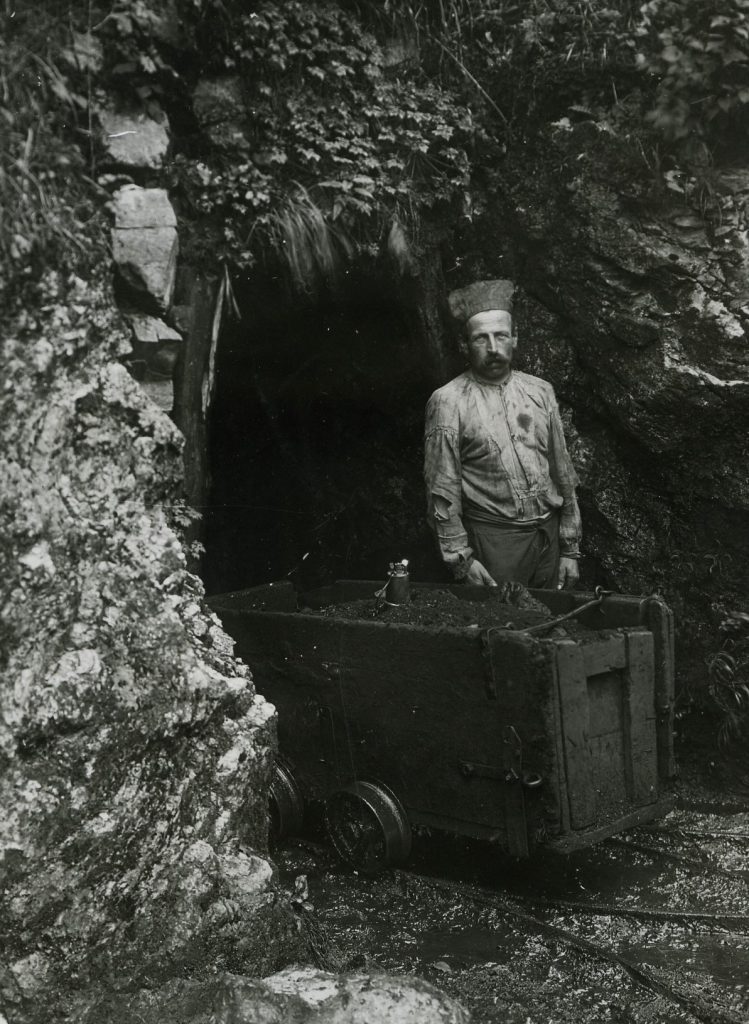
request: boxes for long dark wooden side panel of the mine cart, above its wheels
[217,609,551,846]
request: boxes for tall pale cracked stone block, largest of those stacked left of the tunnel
[112,184,179,311]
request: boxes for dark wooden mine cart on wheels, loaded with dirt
[211,581,674,871]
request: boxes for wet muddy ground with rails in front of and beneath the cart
[277,770,749,1024]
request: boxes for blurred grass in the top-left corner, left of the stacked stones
[0,0,103,307]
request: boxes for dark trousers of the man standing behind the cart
[463,514,559,590]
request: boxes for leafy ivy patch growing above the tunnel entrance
[175,0,473,276]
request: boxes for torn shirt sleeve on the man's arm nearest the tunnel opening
[424,393,472,577]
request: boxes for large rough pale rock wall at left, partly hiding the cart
[0,273,309,1022]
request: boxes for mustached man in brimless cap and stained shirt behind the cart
[424,281,581,589]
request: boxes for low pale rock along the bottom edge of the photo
[88,968,470,1024]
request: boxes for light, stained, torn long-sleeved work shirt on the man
[424,370,582,572]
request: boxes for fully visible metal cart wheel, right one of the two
[325,781,411,874]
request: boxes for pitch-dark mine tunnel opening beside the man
[198,267,454,594]
